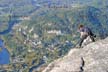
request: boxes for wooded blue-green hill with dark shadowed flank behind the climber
[19,6,108,37]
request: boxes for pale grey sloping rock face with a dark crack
[43,38,108,72]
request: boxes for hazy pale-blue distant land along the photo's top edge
[0,0,108,15]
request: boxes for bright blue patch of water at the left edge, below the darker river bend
[0,39,10,65]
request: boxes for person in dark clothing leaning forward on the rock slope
[78,24,96,48]
